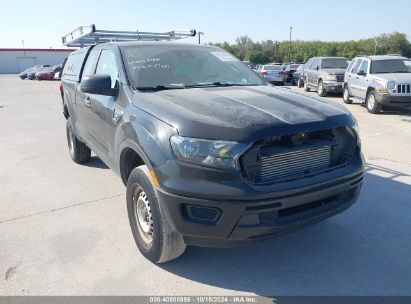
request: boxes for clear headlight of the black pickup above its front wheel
[170,135,248,169]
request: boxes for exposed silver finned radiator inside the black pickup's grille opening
[260,146,331,182]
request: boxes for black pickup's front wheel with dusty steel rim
[127,165,186,263]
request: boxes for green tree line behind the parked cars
[209,32,411,63]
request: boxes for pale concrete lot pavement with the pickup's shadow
[0,75,411,295]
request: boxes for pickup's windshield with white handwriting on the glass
[121,45,264,89]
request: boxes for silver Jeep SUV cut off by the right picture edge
[343,55,411,114]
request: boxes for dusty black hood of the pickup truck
[133,86,353,143]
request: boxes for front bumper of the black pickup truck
[156,166,364,247]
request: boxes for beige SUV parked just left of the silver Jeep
[304,57,348,97]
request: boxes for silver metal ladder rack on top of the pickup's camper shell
[62,24,196,47]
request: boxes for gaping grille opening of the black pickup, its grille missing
[240,127,357,184]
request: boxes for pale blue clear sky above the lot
[0,0,411,48]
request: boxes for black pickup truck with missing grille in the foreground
[62,41,364,263]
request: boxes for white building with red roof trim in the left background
[0,48,74,74]
